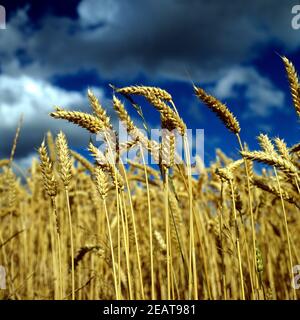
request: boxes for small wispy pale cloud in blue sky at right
[212,67,285,118]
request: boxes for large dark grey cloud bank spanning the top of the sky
[0,0,300,82]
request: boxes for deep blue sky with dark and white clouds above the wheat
[0,0,300,165]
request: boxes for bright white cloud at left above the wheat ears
[0,75,106,161]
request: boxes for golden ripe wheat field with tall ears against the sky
[0,57,300,300]
